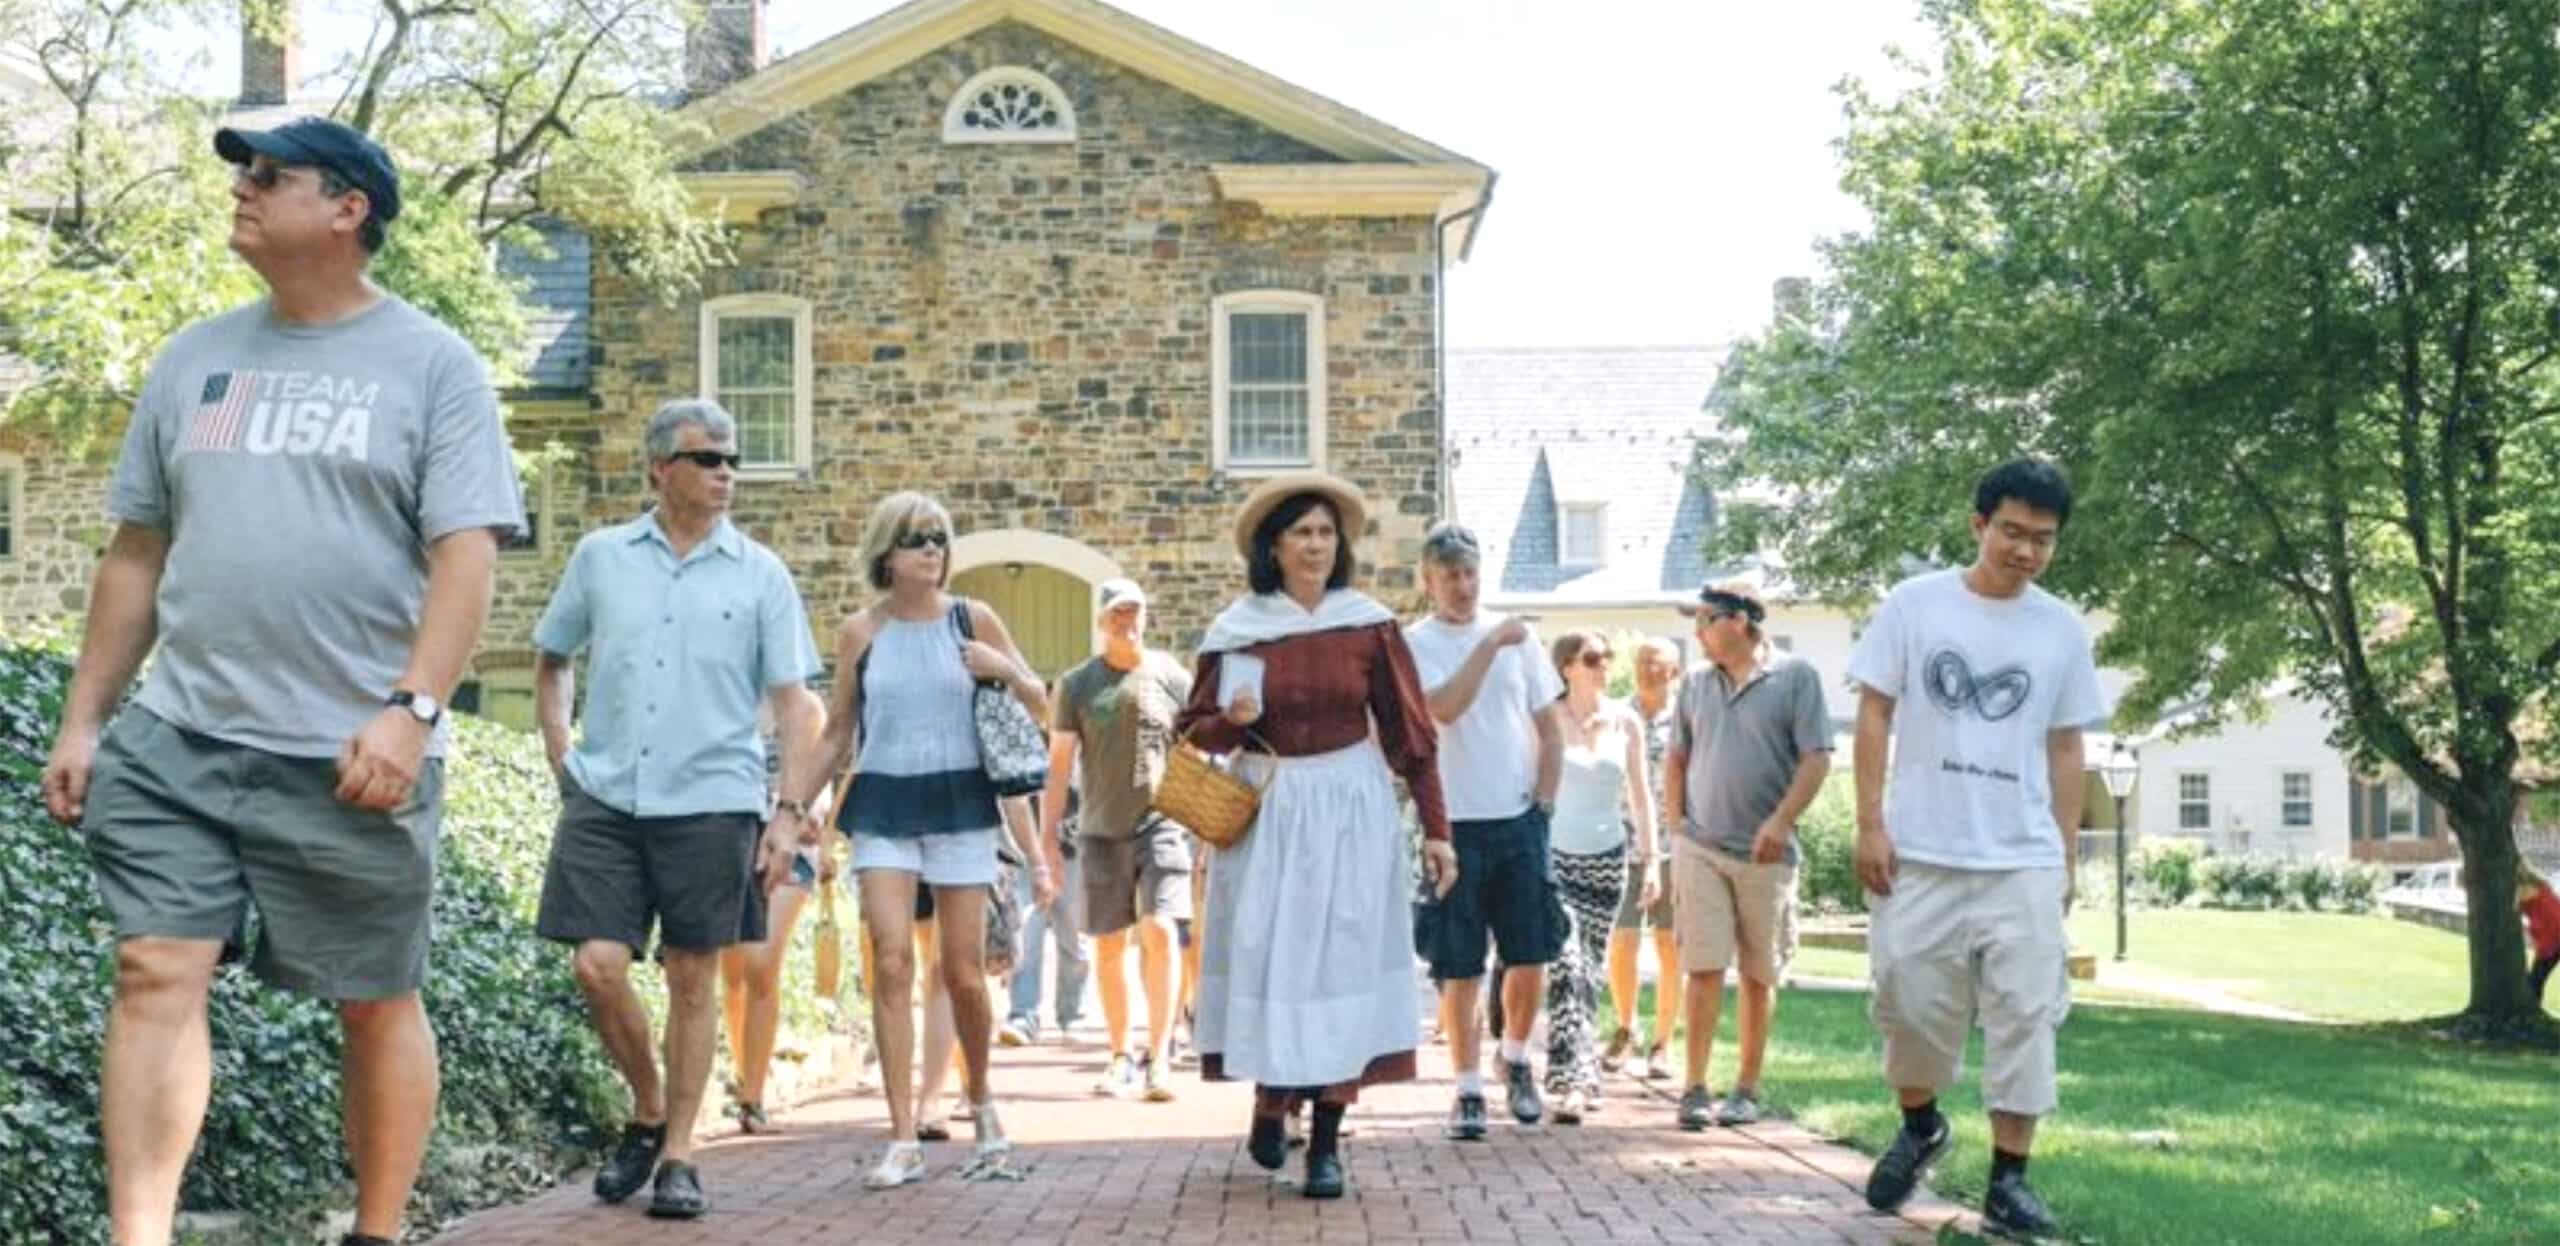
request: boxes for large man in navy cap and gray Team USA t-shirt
[44,118,525,1246]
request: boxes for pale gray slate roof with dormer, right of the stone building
[1449,345,1728,606]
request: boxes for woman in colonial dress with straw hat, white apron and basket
[1178,473,1457,1197]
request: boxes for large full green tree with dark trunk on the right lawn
[1700,0,2560,1034]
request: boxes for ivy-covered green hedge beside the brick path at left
[0,637,622,1246]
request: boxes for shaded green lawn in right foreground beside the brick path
[1607,990,2560,1246]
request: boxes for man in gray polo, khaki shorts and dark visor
[1661,581,1830,1128]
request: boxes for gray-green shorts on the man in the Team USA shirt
[79,706,445,1000]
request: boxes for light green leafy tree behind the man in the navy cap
[0,0,724,448]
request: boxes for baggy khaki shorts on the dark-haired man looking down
[1866,862,2071,1116]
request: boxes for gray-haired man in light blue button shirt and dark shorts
[532,399,824,1220]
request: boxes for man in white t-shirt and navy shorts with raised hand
[1405,519,1564,1141]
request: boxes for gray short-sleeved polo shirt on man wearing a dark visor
[1672,658,1830,865]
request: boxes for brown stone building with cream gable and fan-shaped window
[0,0,1492,719]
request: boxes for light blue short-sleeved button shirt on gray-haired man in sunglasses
[532,512,819,819]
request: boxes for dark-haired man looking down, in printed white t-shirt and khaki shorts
[1848,458,2107,1236]
